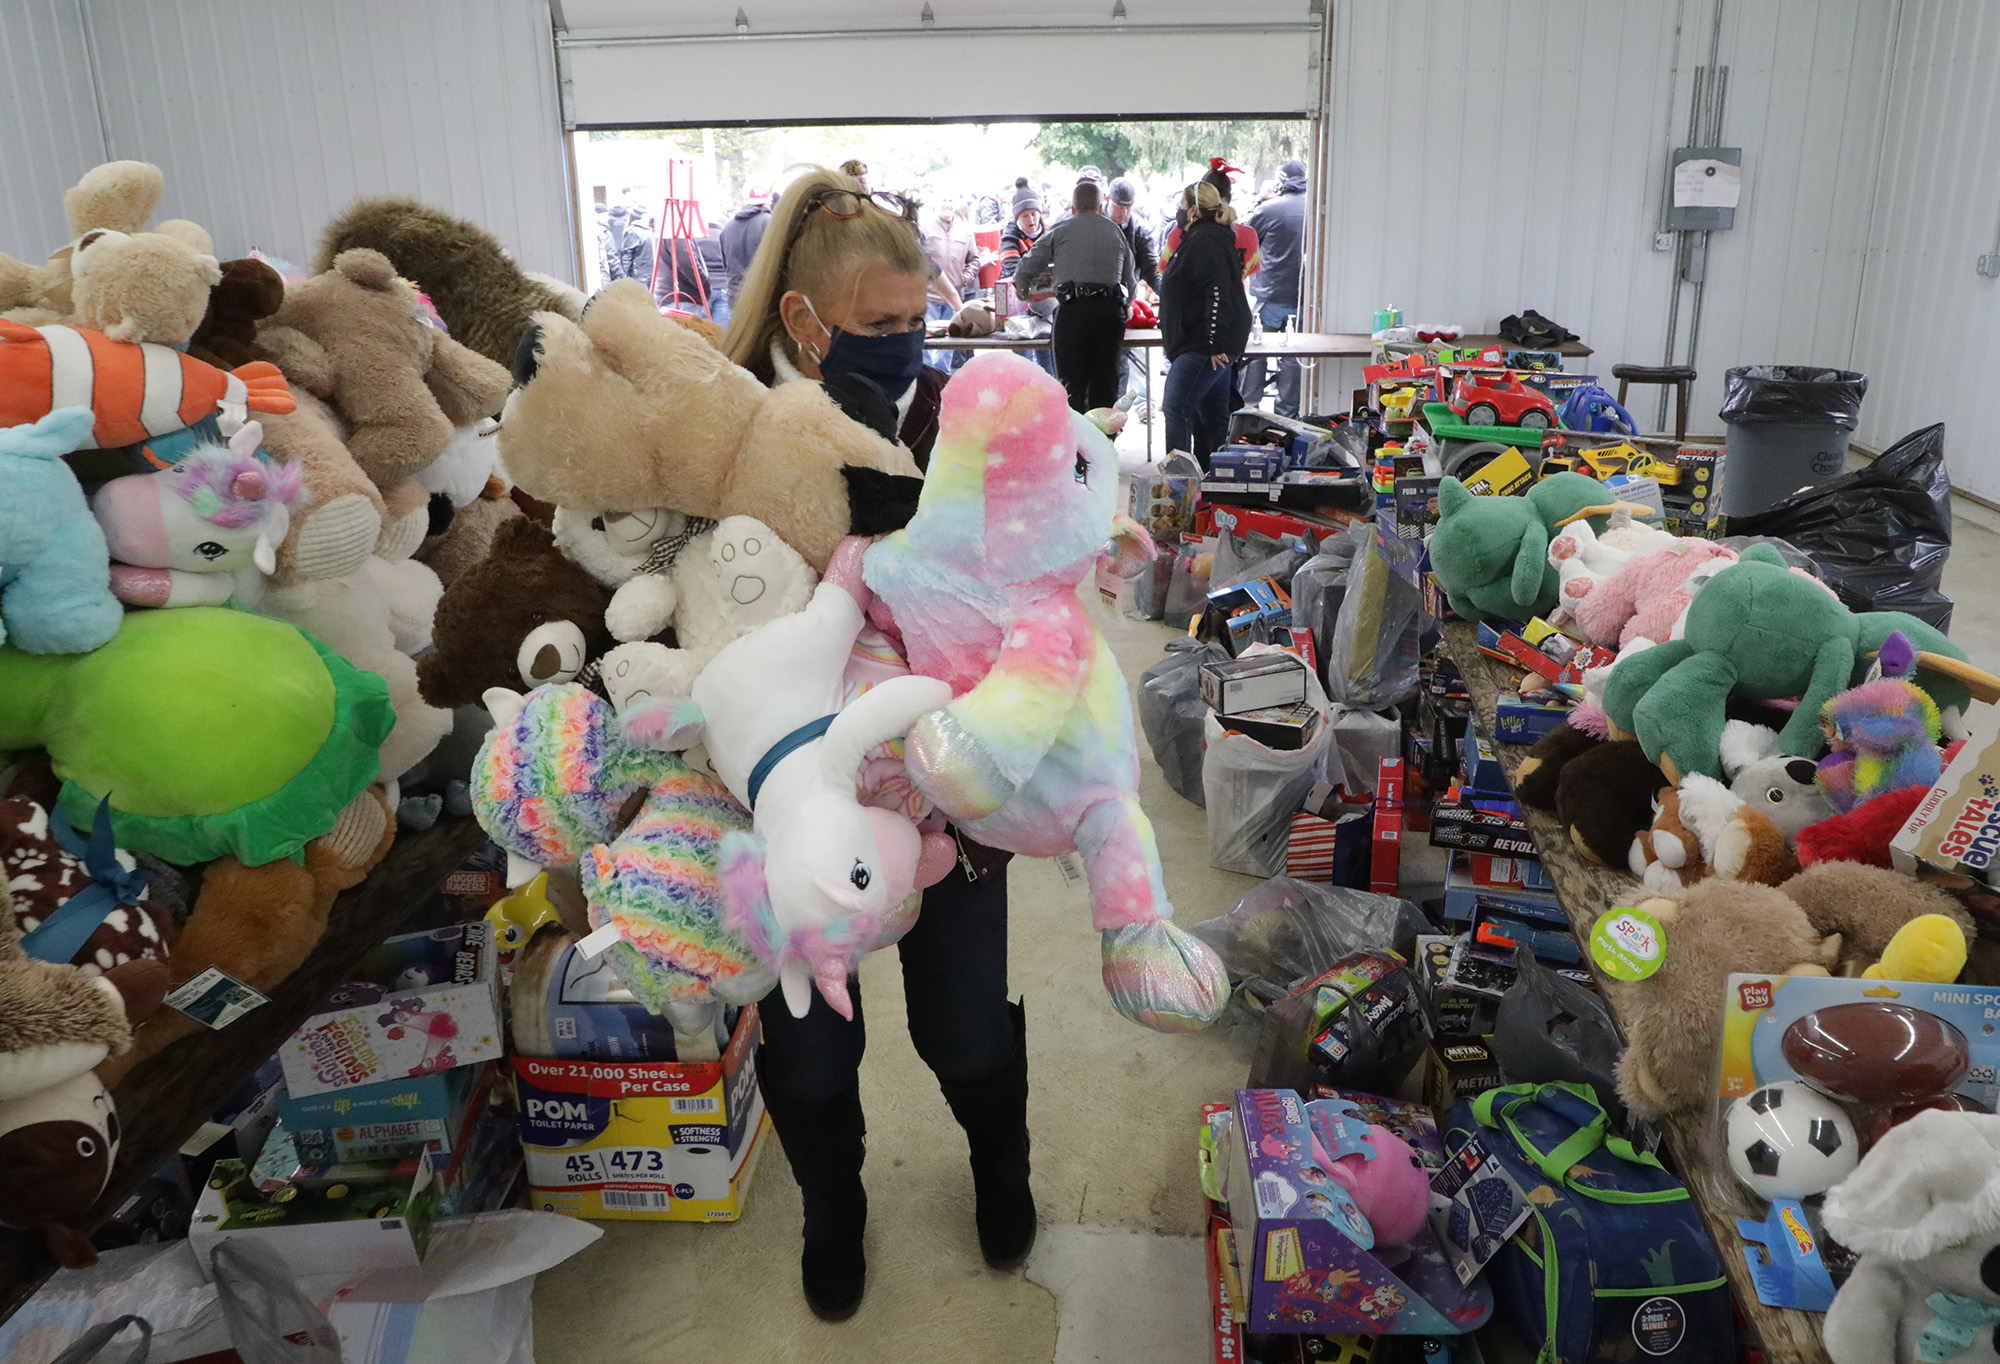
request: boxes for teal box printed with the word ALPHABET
[278,1066,490,1164]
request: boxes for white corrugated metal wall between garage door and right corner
[1324,0,1892,432]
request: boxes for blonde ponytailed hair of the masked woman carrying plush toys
[722,166,936,382]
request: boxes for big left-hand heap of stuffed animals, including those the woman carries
[0,162,1226,1264]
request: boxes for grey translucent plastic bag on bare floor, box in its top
[1202,644,1332,876]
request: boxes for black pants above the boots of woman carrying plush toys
[758,864,1014,1102]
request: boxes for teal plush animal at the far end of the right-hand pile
[1430,472,1612,620]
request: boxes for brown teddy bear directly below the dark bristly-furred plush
[258,250,508,496]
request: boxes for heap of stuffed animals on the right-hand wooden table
[1432,472,2000,1118]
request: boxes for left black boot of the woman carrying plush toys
[764,1088,868,1322]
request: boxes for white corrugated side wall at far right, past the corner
[1854,0,2000,498]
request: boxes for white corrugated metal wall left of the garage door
[0,0,576,278]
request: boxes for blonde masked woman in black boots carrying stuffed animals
[724,168,1036,1320]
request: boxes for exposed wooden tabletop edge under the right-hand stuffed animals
[1444,620,1828,1364]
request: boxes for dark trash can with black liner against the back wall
[1720,364,1868,516]
